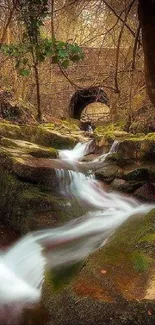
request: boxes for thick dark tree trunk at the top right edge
[138,0,155,106]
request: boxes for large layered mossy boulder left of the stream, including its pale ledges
[0,137,86,233]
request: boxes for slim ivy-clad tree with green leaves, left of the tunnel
[1,0,84,122]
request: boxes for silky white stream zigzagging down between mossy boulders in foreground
[0,139,153,304]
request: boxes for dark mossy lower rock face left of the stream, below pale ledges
[0,166,87,233]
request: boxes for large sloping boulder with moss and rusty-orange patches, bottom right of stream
[43,210,155,325]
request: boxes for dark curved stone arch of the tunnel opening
[70,87,108,120]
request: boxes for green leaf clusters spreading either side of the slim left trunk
[1,38,84,77]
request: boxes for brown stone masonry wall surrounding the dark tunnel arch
[28,48,144,118]
